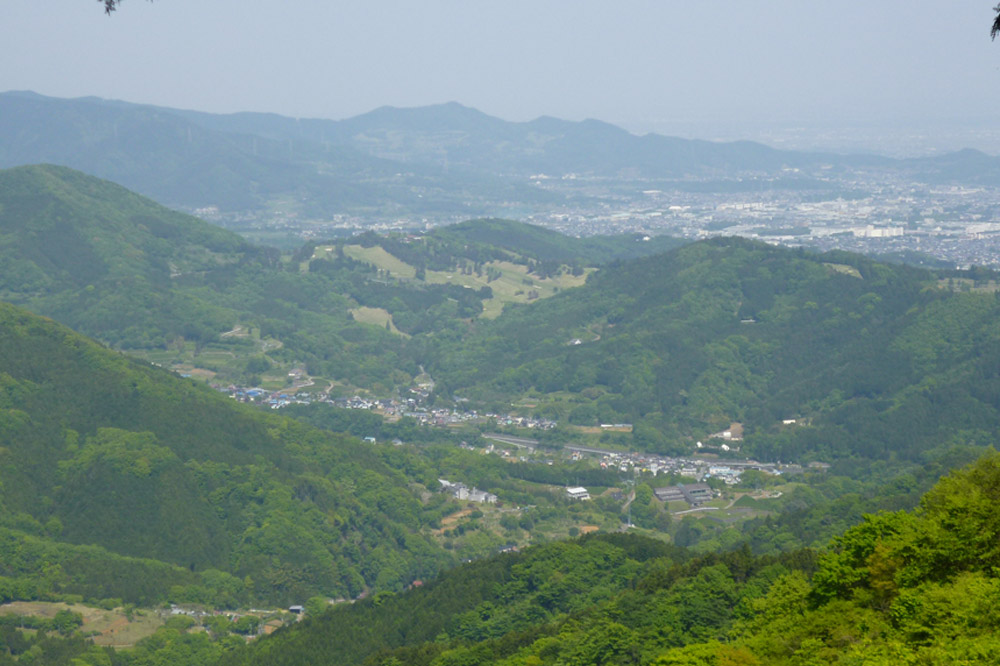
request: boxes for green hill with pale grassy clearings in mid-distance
[298,219,683,322]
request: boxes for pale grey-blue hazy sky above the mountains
[0,0,1000,152]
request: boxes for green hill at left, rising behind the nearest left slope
[0,165,418,386]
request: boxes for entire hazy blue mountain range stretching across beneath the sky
[0,92,1000,217]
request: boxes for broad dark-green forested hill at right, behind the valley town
[428,239,1000,460]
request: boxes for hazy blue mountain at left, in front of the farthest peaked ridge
[0,92,546,217]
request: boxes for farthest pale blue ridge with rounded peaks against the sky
[111,95,877,177]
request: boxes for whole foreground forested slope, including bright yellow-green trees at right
[213,453,1000,666]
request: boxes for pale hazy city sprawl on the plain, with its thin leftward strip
[213,167,1000,268]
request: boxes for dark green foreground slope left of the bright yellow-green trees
[224,535,689,666]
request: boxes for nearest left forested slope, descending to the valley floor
[0,305,451,602]
